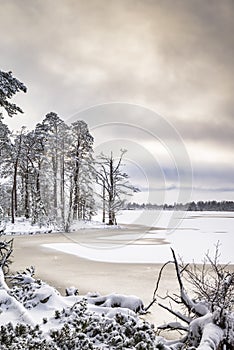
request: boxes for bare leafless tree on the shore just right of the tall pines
[95,149,139,225]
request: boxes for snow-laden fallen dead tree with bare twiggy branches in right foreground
[145,244,234,350]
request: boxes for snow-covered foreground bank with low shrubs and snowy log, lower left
[0,268,163,350]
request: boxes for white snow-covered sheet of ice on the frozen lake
[46,210,234,264]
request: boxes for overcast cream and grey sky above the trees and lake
[0,0,234,203]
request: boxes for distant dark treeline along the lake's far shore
[126,201,234,211]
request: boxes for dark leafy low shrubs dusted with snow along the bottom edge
[0,300,157,350]
